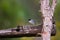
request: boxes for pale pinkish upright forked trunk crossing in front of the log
[40,0,57,40]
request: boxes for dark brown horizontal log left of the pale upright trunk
[0,25,42,38]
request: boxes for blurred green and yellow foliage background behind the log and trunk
[0,0,60,40]
